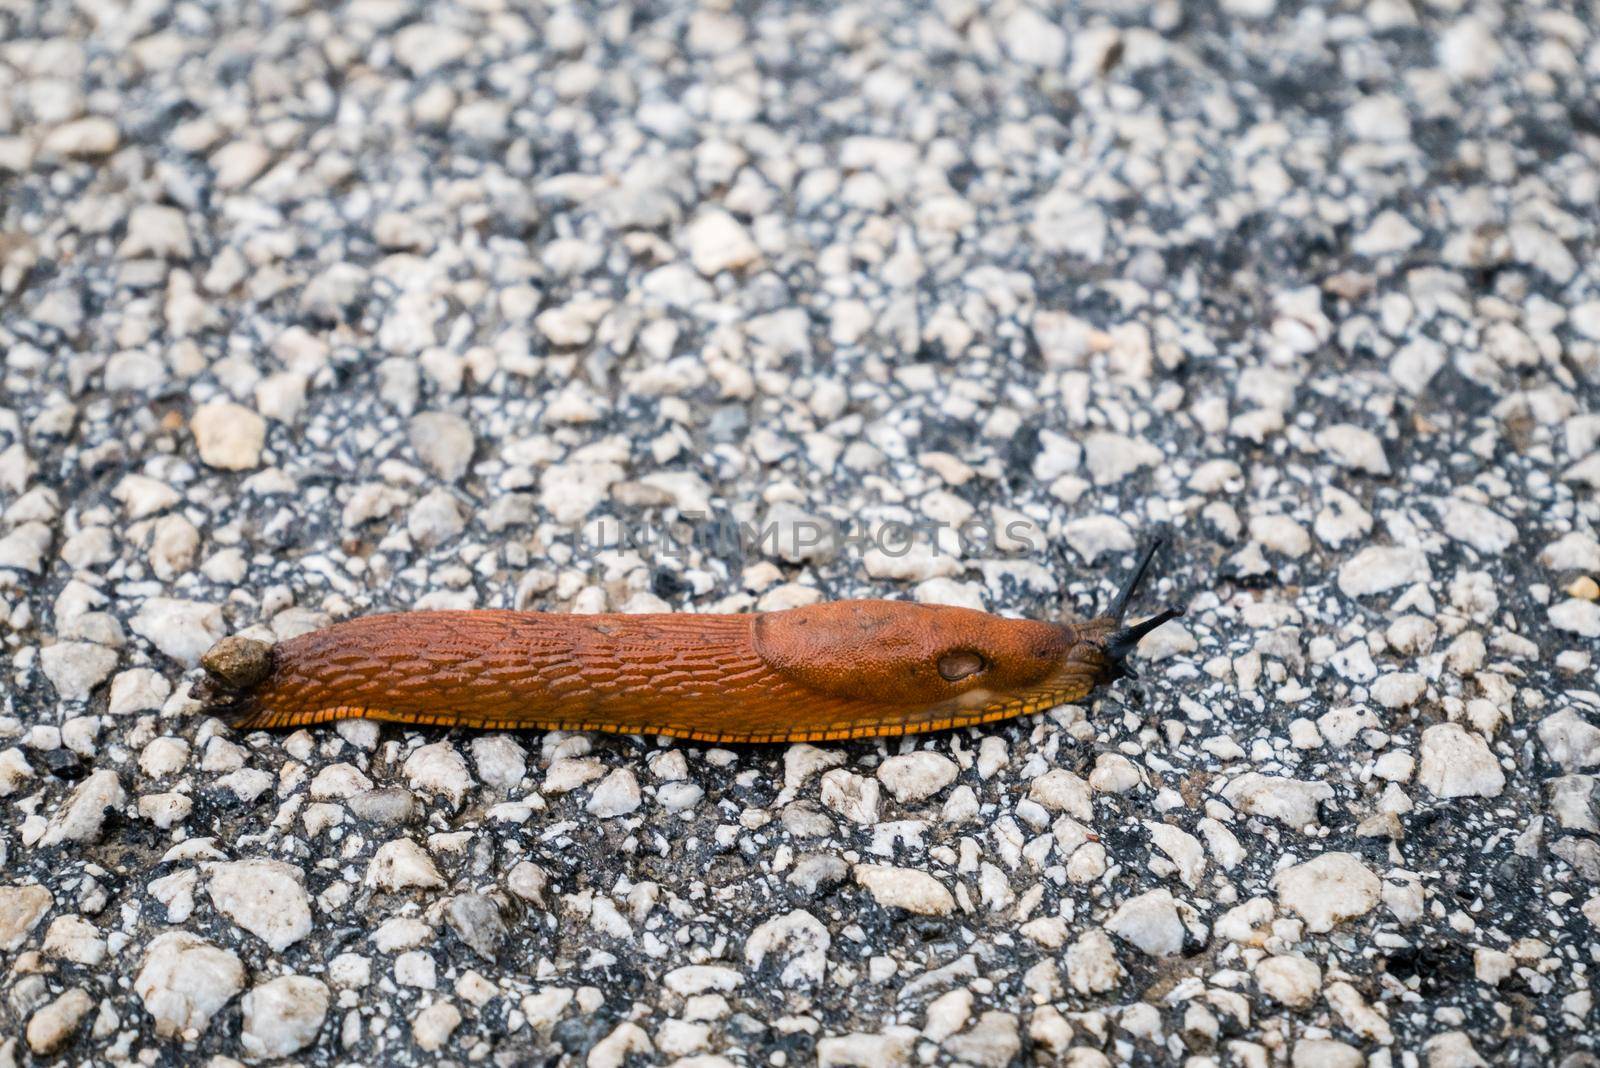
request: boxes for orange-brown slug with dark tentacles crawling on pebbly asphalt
[197,545,1182,743]
